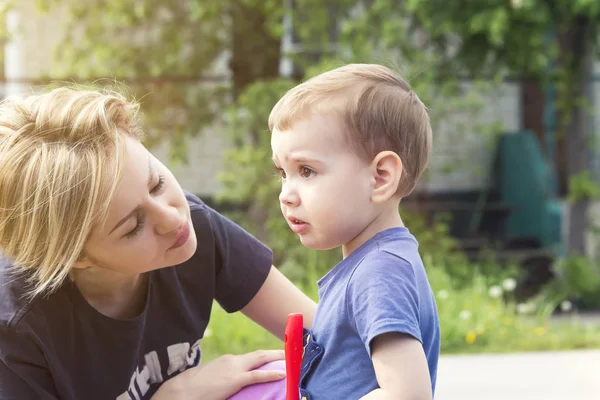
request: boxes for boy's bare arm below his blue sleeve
[361,333,432,400]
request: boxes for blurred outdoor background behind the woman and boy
[0,0,600,399]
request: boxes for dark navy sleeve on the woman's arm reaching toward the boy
[188,193,273,312]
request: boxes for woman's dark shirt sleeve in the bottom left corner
[0,326,59,400]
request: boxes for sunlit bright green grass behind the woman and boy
[202,293,600,360]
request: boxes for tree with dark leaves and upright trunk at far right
[406,0,600,255]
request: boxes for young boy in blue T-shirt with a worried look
[269,64,440,400]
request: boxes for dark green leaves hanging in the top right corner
[407,0,600,76]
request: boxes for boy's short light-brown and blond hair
[269,64,432,197]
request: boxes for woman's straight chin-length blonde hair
[0,88,142,296]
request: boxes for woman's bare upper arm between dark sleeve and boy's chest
[242,267,317,340]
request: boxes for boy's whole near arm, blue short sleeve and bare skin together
[347,250,432,400]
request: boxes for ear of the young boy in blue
[371,151,404,203]
